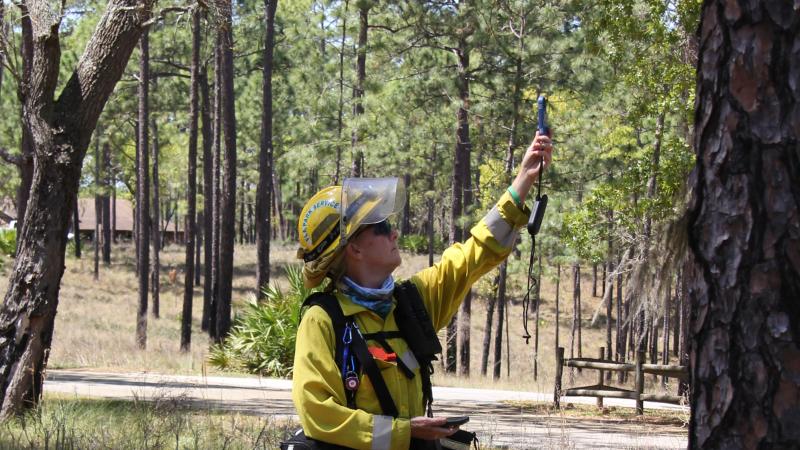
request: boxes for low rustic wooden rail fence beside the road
[553,347,689,415]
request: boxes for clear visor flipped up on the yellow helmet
[339,178,406,245]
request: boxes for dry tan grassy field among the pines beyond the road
[0,239,688,400]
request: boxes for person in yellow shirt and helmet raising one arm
[292,133,552,449]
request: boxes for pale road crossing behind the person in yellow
[45,370,687,449]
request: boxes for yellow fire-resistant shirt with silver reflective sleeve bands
[292,192,530,449]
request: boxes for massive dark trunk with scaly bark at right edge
[686,0,800,448]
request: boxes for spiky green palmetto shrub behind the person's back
[209,266,313,377]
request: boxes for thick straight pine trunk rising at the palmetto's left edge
[216,1,236,342]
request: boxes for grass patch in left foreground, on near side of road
[0,395,295,450]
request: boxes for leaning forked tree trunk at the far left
[0,0,150,418]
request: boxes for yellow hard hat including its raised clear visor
[297,178,405,263]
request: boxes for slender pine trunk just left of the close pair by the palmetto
[181,8,200,352]
